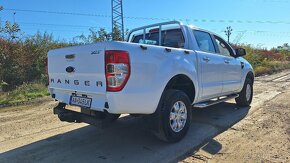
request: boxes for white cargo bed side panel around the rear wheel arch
[106,42,199,114]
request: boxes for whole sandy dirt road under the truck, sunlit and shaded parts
[0,70,290,162]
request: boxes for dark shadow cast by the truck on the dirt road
[0,103,250,162]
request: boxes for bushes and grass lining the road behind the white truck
[0,19,290,105]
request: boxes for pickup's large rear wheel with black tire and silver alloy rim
[150,90,192,143]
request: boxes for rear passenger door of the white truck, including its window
[193,30,224,100]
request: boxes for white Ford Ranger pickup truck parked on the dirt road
[48,21,254,142]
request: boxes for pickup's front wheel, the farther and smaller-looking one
[235,78,253,106]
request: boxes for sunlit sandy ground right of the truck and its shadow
[180,71,290,162]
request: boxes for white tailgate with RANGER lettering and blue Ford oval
[48,43,106,94]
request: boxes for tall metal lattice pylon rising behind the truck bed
[112,0,124,40]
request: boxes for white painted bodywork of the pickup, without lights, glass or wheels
[48,22,253,114]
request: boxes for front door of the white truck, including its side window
[214,35,242,94]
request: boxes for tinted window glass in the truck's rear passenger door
[193,31,216,53]
